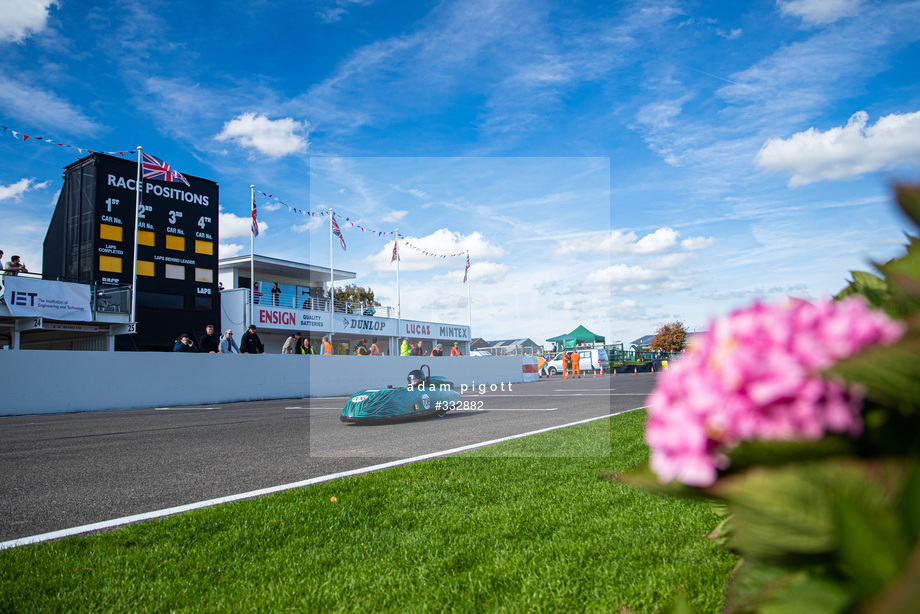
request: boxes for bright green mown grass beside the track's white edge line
[0,411,736,612]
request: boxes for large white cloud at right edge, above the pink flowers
[756,111,920,186]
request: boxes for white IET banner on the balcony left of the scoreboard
[3,275,93,322]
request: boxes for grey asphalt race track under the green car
[0,374,656,542]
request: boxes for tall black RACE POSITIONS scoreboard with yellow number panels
[44,154,220,349]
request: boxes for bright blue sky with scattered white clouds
[0,0,920,342]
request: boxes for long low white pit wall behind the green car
[0,350,523,416]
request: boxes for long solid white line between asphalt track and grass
[0,407,642,550]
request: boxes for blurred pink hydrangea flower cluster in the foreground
[645,296,905,487]
